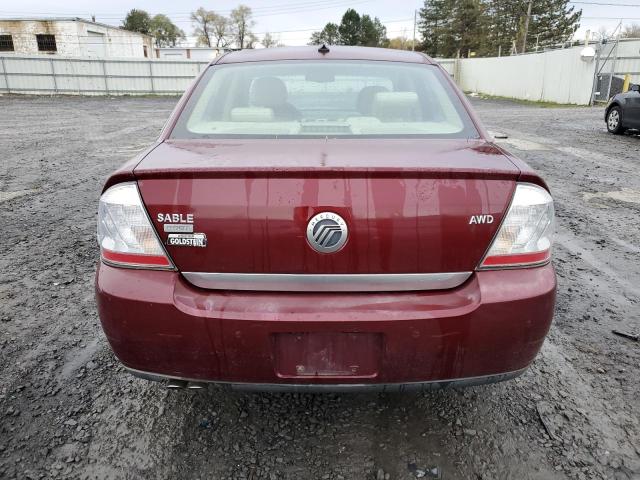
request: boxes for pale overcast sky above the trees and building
[0,0,640,45]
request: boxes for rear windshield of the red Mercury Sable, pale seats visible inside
[171,60,478,139]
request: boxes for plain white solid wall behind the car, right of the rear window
[456,47,595,105]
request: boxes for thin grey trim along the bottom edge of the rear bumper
[123,365,529,393]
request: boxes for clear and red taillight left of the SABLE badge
[98,183,173,269]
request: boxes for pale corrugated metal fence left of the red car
[0,55,209,95]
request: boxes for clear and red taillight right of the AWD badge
[480,183,554,268]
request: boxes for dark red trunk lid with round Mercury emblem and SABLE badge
[134,139,520,274]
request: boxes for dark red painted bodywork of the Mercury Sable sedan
[96,47,556,384]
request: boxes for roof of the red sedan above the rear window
[211,45,436,64]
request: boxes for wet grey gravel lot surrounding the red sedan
[0,96,640,479]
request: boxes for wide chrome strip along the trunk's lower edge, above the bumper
[182,272,472,292]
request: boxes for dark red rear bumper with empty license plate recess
[96,264,556,391]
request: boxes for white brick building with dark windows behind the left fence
[0,18,153,58]
